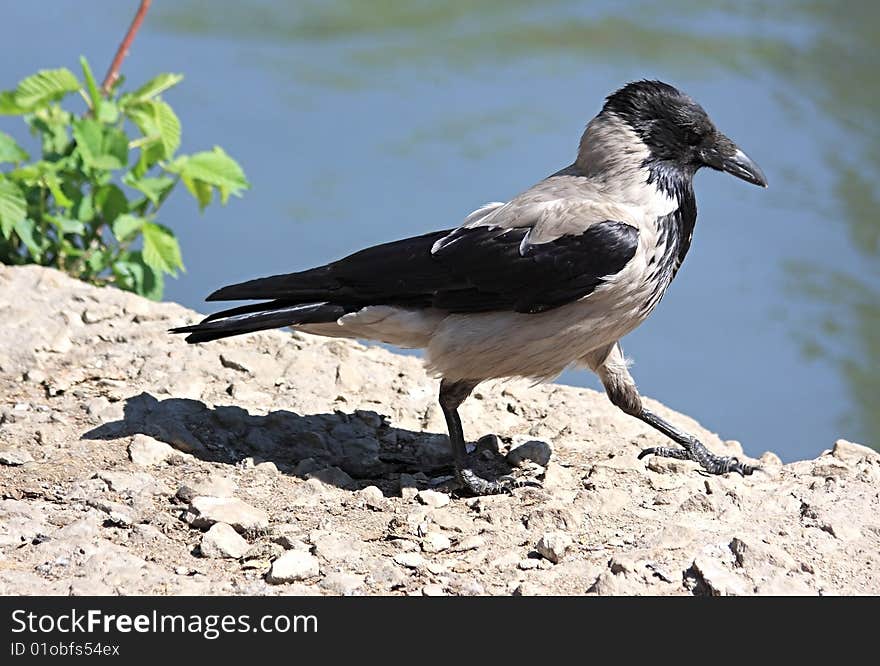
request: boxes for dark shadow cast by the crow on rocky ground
[82,393,510,495]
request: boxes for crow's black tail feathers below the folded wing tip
[169,301,351,344]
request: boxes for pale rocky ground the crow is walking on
[0,266,880,595]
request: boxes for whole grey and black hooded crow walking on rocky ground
[174,81,766,494]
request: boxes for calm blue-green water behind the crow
[0,0,880,460]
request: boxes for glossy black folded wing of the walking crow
[208,221,638,313]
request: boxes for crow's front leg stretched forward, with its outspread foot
[586,343,758,476]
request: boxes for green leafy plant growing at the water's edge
[0,58,249,299]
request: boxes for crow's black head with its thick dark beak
[600,81,767,187]
